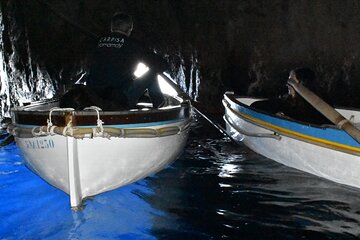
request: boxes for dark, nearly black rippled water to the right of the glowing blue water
[143,113,360,239]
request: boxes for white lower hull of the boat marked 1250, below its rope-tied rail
[15,124,188,202]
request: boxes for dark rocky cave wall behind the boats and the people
[1,0,360,116]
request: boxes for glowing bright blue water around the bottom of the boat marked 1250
[0,142,162,239]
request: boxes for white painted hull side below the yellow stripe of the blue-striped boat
[225,95,360,188]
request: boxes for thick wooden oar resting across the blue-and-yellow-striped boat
[288,75,360,143]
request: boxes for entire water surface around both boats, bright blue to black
[0,117,360,240]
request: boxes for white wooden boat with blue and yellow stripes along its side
[223,92,360,188]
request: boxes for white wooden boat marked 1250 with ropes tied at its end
[9,76,191,208]
